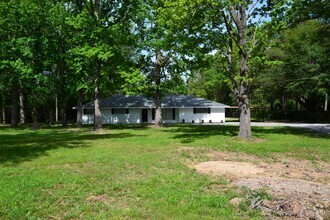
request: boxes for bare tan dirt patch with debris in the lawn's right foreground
[180,148,330,220]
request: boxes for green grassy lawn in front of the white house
[0,125,330,219]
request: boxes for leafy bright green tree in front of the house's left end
[69,0,139,130]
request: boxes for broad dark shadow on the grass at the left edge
[0,127,146,166]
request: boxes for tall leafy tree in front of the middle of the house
[137,0,189,126]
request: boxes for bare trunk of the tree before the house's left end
[94,60,102,130]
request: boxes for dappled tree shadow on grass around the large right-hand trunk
[165,125,330,143]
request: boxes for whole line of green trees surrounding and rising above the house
[0,0,330,129]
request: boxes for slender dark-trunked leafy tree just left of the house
[46,1,73,127]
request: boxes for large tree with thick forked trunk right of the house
[158,0,286,139]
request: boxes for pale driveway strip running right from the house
[225,122,330,135]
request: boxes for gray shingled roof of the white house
[83,95,230,109]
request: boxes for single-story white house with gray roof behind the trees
[82,95,230,124]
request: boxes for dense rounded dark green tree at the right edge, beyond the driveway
[259,20,330,111]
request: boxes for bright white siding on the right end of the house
[179,108,225,123]
